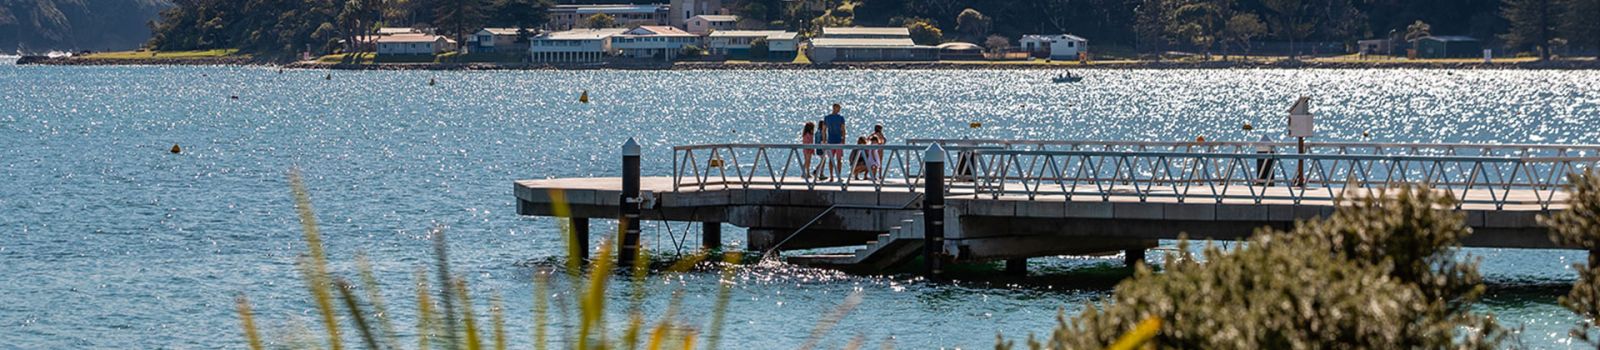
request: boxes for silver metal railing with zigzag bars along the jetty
[672,141,1600,209]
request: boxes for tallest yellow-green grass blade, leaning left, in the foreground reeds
[290,169,344,350]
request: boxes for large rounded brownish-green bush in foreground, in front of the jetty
[1030,189,1506,348]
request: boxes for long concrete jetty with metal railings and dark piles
[514,139,1600,275]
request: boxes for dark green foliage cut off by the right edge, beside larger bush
[1539,169,1600,345]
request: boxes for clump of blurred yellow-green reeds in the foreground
[237,171,859,350]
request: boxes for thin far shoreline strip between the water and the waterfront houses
[16,56,1600,70]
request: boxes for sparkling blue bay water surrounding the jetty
[0,66,1600,348]
